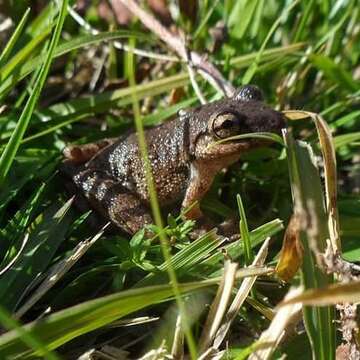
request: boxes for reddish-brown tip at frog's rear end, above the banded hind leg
[63,138,116,165]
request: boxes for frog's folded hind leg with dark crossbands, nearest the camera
[73,169,153,234]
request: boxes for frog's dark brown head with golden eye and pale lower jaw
[190,85,286,159]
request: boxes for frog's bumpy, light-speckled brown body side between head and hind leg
[87,119,189,205]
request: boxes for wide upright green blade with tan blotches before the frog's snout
[285,133,335,360]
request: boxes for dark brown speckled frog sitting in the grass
[61,85,286,235]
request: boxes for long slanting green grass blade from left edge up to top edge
[0,0,68,186]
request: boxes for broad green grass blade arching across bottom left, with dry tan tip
[0,268,269,359]
